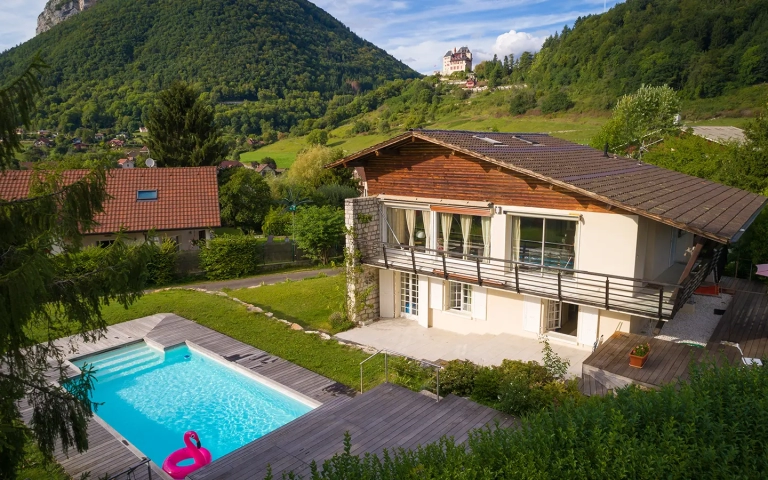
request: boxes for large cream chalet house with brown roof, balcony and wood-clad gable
[329,130,768,347]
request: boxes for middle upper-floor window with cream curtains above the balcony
[437,212,491,257]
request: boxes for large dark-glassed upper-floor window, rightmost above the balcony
[512,217,577,270]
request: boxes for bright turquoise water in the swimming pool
[69,342,312,465]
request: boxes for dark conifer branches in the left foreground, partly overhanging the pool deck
[0,59,151,478]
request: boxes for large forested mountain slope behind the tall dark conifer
[0,0,419,134]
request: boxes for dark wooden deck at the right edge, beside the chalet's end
[710,278,768,359]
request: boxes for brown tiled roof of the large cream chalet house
[328,130,768,243]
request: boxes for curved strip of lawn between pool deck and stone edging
[97,282,384,389]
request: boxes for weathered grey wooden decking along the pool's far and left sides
[37,314,355,480]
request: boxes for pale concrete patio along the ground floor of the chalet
[336,318,591,376]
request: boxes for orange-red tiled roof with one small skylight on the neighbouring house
[0,167,221,234]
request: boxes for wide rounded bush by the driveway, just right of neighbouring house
[200,235,264,280]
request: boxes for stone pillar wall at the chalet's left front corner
[345,197,381,324]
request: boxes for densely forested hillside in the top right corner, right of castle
[526,0,768,107]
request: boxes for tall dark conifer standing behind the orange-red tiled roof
[147,82,227,167]
